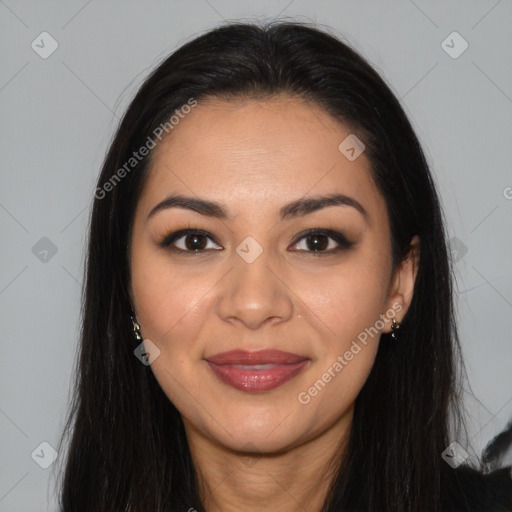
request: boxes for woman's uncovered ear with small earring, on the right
[382,235,420,332]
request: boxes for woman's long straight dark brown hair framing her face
[53,22,480,512]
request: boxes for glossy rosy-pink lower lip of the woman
[206,359,309,392]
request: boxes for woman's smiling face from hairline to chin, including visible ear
[131,96,418,453]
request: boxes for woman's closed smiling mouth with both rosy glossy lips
[205,350,310,392]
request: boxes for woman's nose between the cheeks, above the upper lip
[217,251,294,330]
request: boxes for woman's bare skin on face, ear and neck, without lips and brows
[130,96,419,512]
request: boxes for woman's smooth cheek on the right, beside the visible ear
[294,248,388,396]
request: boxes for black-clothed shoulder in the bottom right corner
[445,465,512,512]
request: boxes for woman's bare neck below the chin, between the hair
[185,416,348,512]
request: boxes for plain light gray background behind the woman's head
[0,0,512,512]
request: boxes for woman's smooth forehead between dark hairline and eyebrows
[141,96,384,224]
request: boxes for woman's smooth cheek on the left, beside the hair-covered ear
[132,249,218,416]
